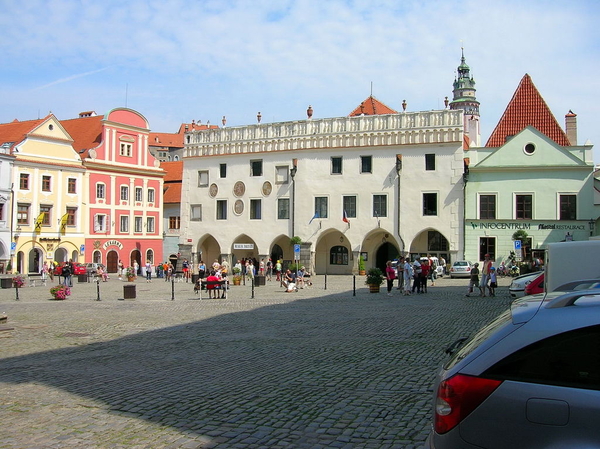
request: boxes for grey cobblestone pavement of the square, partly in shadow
[0,276,510,448]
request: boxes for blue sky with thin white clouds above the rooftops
[0,0,600,163]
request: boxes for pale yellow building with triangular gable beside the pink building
[0,114,87,273]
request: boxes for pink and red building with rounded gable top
[61,108,164,273]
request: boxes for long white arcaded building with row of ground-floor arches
[180,96,464,274]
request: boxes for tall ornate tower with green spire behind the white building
[450,48,481,147]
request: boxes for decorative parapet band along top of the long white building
[184,110,463,157]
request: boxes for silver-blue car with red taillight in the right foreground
[426,289,600,449]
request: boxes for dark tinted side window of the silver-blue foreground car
[483,325,600,390]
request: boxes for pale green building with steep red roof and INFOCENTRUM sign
[464,75,600,263]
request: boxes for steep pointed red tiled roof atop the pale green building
[485,74,571,147]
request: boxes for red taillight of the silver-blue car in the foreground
[434,374,502,434]
